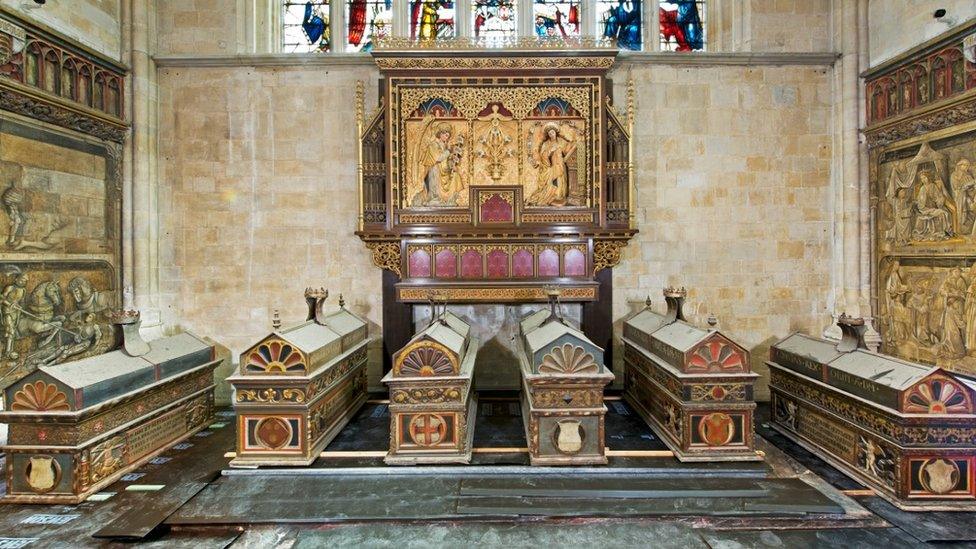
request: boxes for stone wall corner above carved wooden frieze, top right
[868,0,976,67]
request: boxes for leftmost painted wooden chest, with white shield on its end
[0,311,220,503]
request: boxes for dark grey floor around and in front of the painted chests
[0,400,976,549]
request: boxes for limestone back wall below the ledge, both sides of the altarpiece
[158,64,832,394]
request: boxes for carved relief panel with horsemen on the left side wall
[0,116,121,386]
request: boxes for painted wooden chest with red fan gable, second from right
[623,288,762,461]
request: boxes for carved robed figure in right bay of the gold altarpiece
[528,122,577,206]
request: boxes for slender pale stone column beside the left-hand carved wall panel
[123,0,162,337]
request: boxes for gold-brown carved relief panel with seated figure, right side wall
[873,124,976,375]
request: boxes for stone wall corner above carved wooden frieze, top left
[0,0,122,60]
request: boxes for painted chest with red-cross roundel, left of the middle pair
[383,311,478,465]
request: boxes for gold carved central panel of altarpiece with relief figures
[389,77,602,210]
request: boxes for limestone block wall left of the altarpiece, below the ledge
[158,66,382,383]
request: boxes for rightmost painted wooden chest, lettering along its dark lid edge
[767,317,976,510]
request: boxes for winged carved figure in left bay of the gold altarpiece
[410,117,464,206]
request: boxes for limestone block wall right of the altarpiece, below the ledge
[613,65,833,398]
